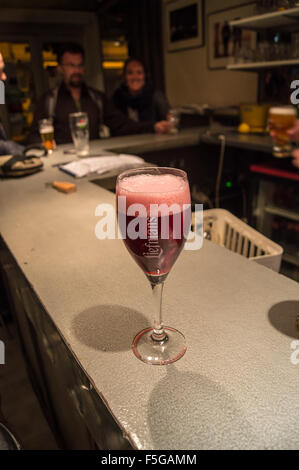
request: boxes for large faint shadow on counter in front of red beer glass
[148,365,263,450]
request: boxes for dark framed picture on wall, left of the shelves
[165,0,204,52]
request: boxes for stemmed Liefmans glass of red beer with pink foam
[116,167,191,365]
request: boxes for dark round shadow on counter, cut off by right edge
[268,300,299,339]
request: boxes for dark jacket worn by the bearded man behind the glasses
[28,83,154,144]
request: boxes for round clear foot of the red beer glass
[132,326,187,365]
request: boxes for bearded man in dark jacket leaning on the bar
[29,44,171,144]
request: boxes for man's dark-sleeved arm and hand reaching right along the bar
[103,92,171,137]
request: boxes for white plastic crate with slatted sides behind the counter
[195,209,283,272]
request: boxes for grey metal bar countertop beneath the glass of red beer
[0,131,299,449]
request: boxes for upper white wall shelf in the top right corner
[229,7,299,30]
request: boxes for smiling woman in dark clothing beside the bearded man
[113,58,169,122]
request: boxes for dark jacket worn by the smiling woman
[113,83,169,122]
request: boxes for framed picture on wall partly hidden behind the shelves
[207,3,256,69]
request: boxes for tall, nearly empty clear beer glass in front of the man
[69,112,89,157]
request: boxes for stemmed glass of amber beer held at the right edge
[268,106,297,157]
